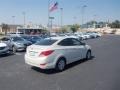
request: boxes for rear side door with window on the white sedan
[58,38,80,63]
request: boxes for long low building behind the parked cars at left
[0,25,45,34]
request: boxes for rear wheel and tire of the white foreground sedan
[55,58,66,72]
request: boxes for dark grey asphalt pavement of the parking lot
[0,35,120,90]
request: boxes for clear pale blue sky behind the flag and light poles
[0,0,120,25]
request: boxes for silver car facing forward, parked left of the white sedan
[1,36,32,53]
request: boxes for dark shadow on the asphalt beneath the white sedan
[31,56,95,74]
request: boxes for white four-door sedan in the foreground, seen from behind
[25,37,91,71]
